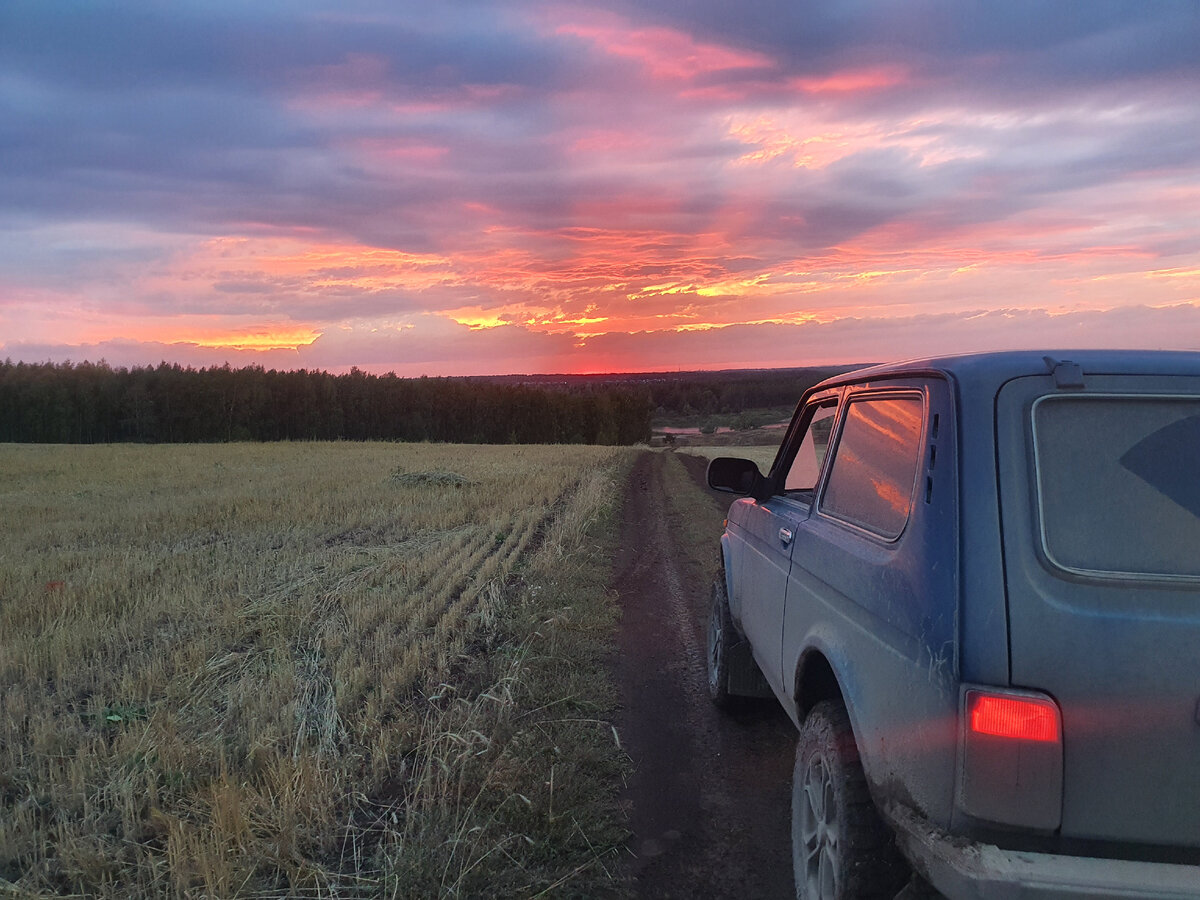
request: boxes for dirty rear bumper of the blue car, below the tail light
[887,806,1200,900]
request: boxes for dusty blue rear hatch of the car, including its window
[997,376,1200,847]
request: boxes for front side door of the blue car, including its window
[740,389,840,696]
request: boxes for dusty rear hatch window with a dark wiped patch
[1033,395,1200,578]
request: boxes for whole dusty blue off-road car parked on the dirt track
[708,350,1200,898]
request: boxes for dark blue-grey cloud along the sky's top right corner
[608,0,1200,96]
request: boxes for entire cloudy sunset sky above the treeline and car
[0,0,1200,376]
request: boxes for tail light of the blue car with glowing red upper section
[959,688,1062,830]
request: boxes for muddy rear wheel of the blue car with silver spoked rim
[792,700,908,900]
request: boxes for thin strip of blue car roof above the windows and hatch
[814,349,1200,391]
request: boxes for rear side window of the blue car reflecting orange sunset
[821,394,925,540]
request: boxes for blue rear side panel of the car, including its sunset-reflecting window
[782,377,958,810]
